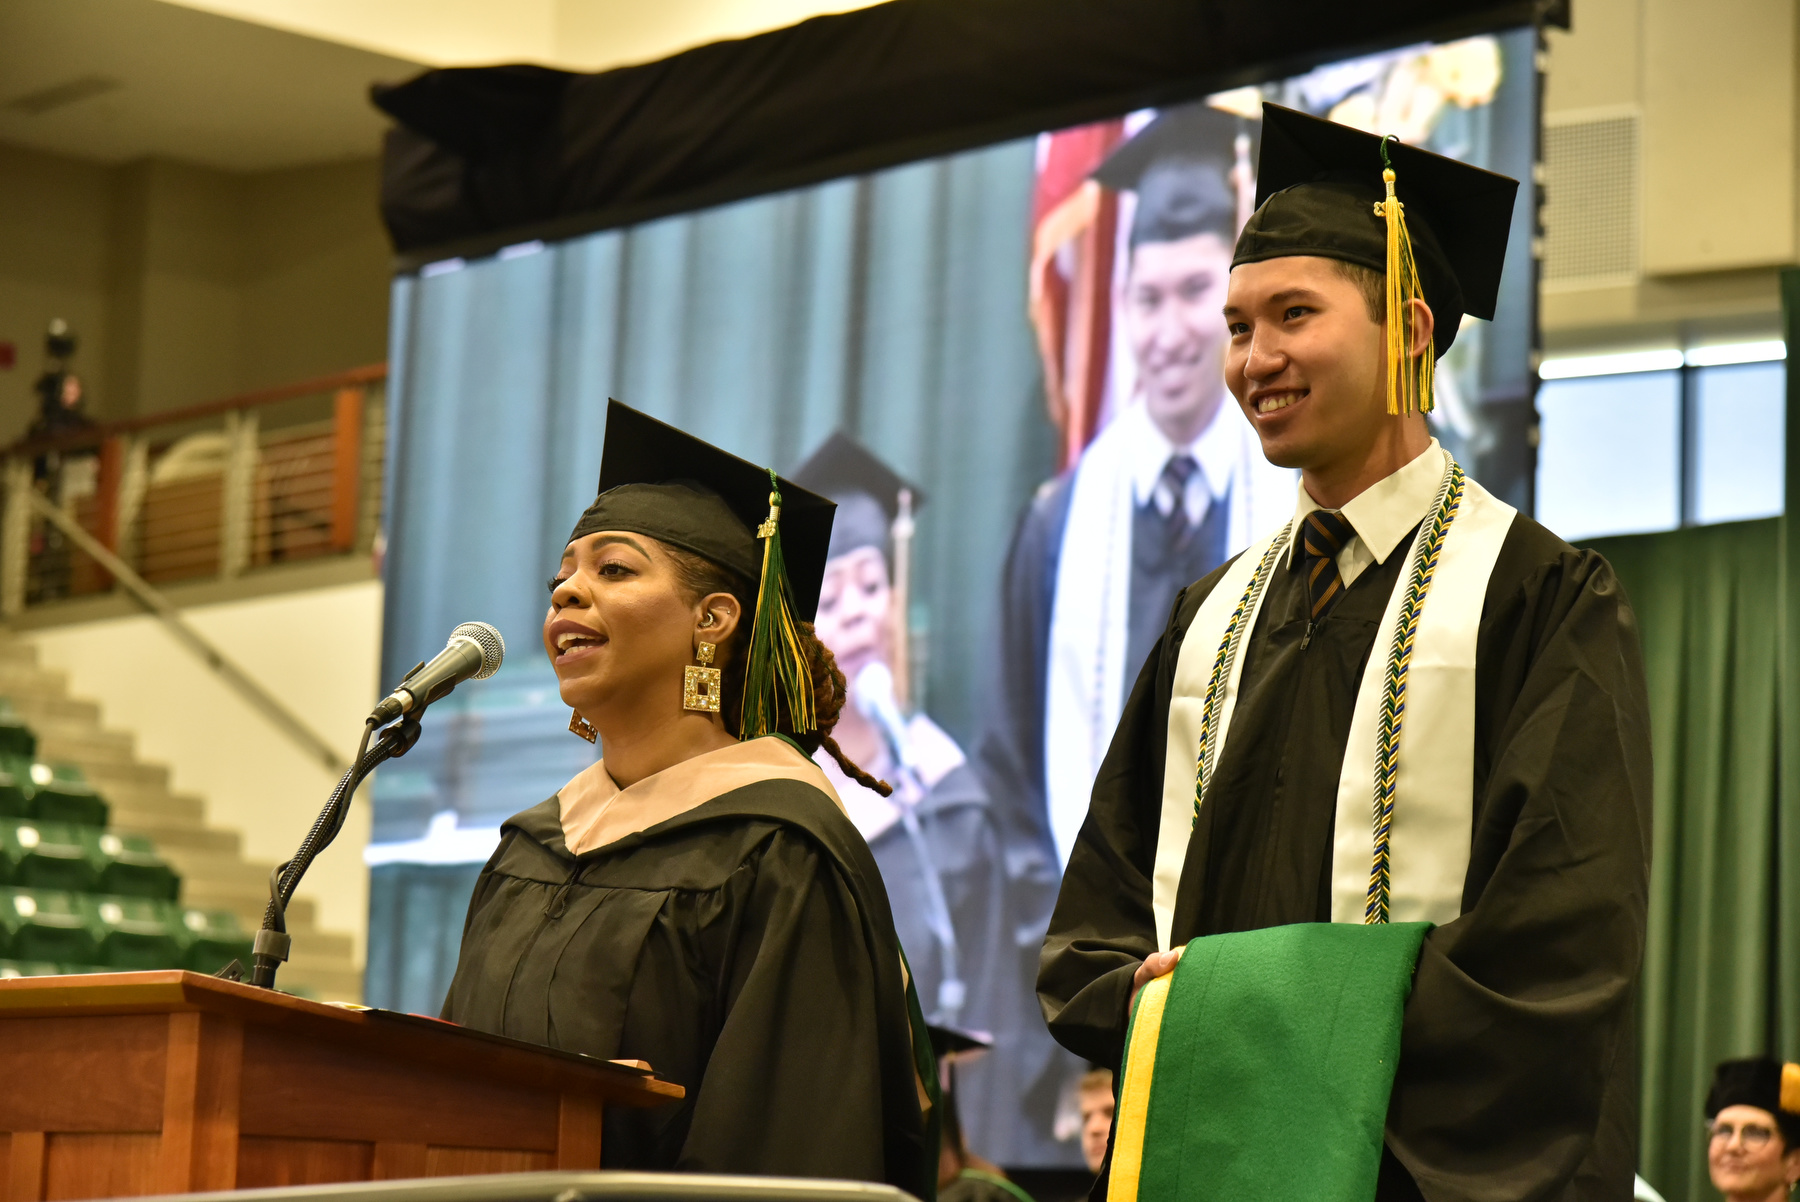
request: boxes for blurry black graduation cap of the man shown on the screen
[1094,101,1255,247]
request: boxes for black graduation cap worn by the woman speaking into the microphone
[569,401,837,623]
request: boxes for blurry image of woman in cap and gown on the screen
[794,432,1057,1162]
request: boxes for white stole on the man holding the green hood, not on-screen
[1152,452,1516,950]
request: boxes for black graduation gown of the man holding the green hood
[1039,516,1651,1202]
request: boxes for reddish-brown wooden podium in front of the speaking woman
[0,972,682,1202]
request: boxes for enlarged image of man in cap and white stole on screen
[979,104,1294,860]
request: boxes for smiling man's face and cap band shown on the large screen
[1116,154,1237,446]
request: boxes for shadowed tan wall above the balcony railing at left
[0,146,391,439]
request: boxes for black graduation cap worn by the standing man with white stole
[1231,104,1519,354]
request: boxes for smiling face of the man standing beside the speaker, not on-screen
[1226,256,1388,470]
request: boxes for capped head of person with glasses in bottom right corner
[1706,1056,1800,1202]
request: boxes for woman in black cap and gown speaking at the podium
[443,401,938,1198]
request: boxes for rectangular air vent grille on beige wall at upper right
[1544,110,1638,292]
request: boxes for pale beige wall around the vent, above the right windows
[1543,0,1800,353]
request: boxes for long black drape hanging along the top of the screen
[374,0,1548,266]
